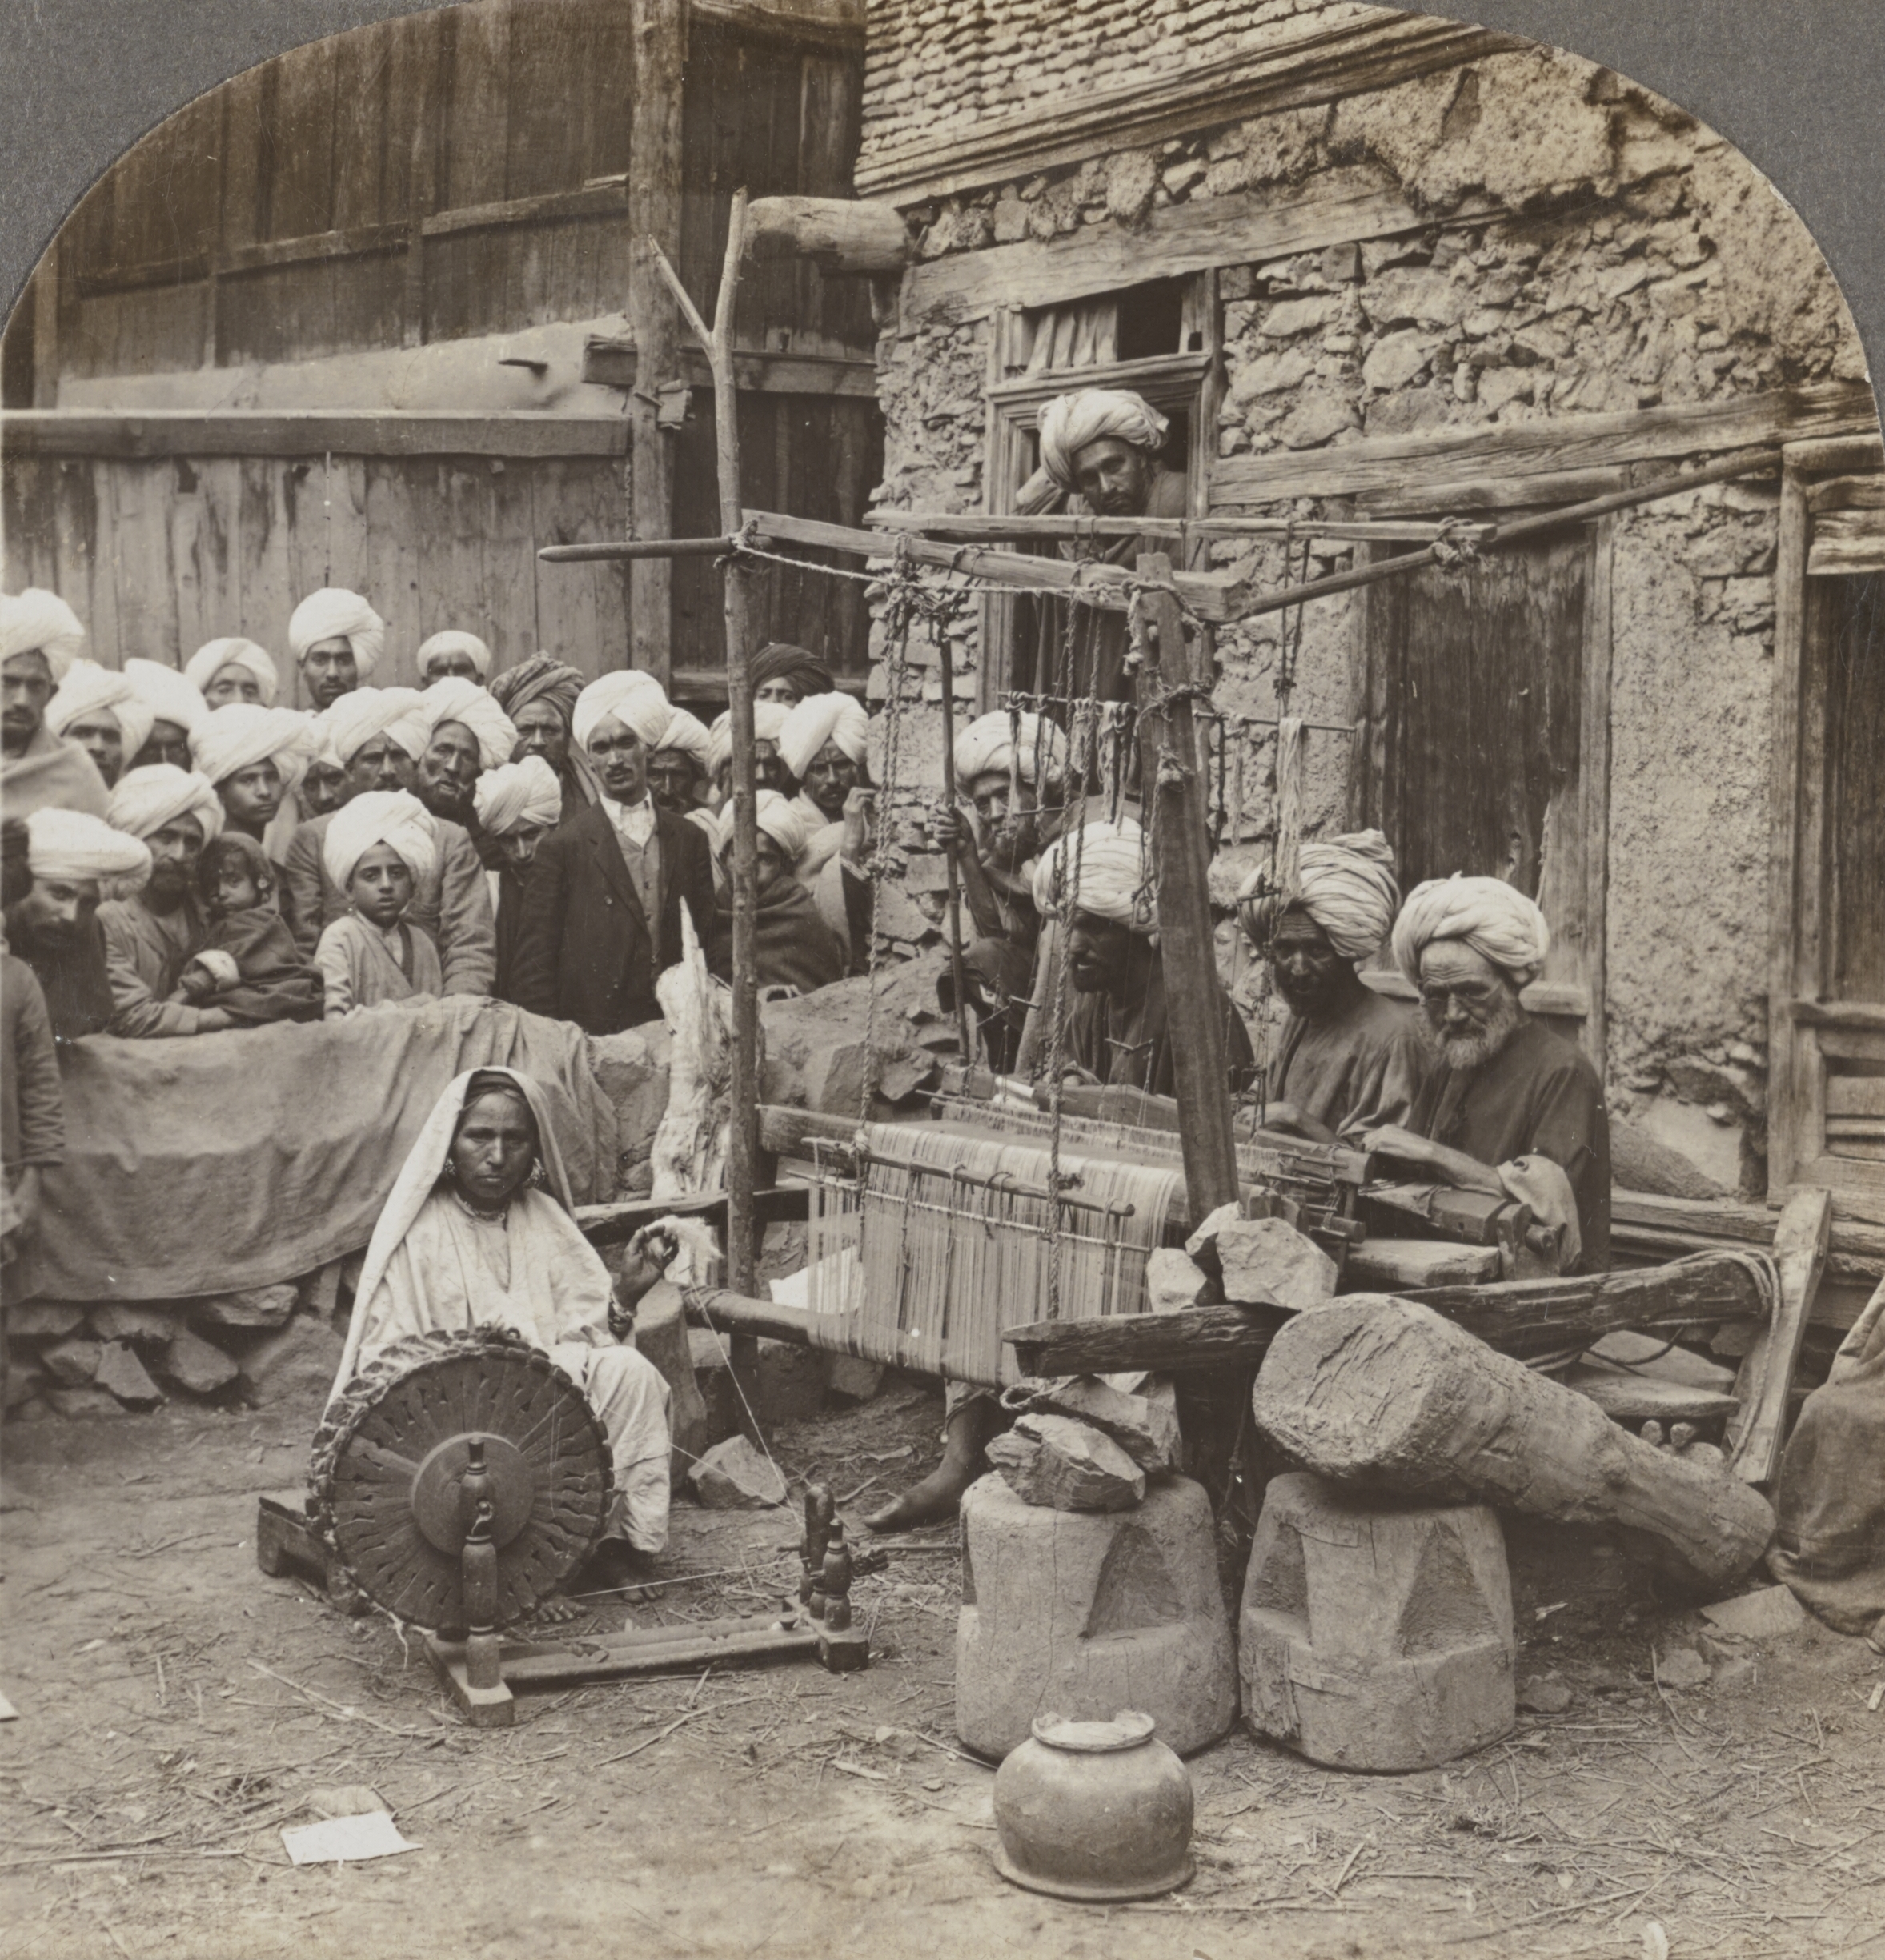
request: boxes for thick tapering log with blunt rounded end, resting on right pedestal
[1252,1293,1773,1588]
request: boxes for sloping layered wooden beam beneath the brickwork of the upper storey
[856,10,1532,203]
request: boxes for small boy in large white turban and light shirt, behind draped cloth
[314,790,445,1021]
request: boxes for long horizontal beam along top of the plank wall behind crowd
[0,407,627,459]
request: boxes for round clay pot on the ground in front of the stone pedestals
[993,1711,1191,1899]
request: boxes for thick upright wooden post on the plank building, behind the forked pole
[629,0,688,686]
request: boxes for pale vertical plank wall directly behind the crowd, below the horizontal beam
[0,457,627,706]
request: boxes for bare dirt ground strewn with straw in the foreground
[0,1385,1885,1960]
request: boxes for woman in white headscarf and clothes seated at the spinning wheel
[329,1068,670,1585]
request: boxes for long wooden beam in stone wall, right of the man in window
[1214,382,1877,510]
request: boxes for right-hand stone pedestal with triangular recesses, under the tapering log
[1238,1474,1517,1770]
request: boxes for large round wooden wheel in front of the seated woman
[310,1327,612,1638]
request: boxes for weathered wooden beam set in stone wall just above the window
[897,186,1473,329]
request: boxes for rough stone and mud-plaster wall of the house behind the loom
[864,18,1863,1190]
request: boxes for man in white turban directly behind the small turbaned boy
[283,688,498,994]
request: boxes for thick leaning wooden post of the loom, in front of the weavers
[1138,551,1238,1223]
